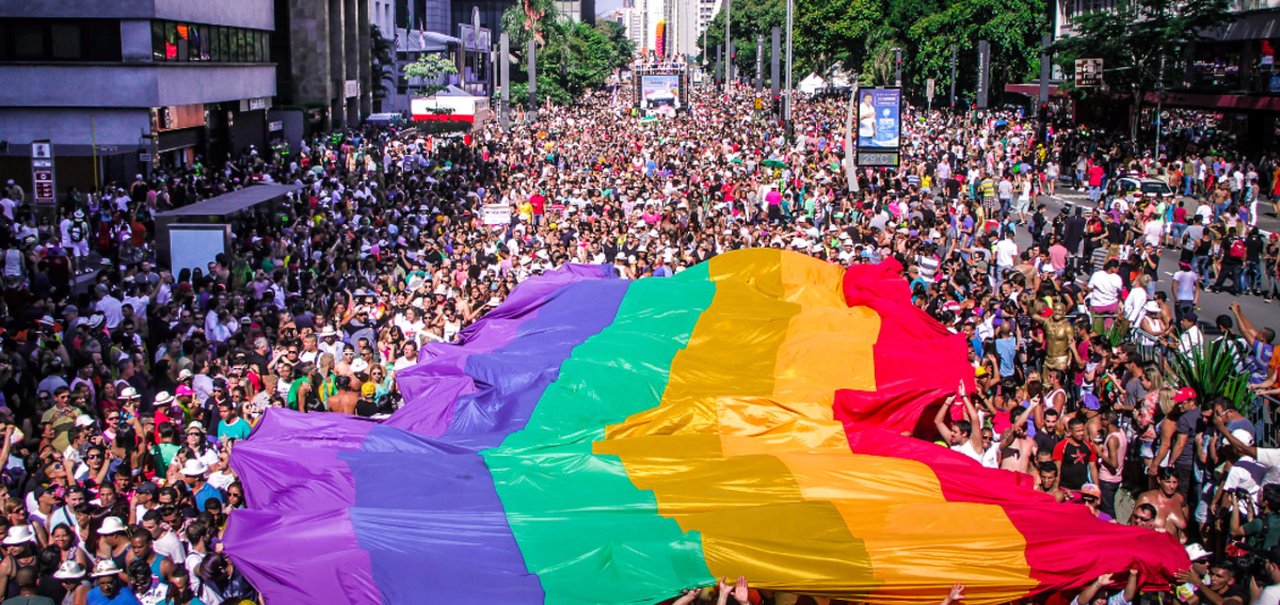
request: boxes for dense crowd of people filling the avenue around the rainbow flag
[0,76,1280,605]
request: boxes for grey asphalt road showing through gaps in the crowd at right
[1014,187,1280,334]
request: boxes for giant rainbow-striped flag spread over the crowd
[225,249,1188,605]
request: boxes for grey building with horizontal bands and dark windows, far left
[0,0,278,189]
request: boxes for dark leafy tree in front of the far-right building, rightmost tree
[1051,0,1230,138]
